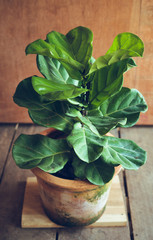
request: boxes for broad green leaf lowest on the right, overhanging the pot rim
[101,136,146,170]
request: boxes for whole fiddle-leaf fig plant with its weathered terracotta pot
[13,26,147,226]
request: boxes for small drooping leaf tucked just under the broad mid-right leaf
[88,116,127,135]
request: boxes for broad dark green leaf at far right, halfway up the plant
[100,87,147,127]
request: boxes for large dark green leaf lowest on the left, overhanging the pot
[13,134,70,173]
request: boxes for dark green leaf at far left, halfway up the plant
[13,78,73,131]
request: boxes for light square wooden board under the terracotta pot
[21,176,127,228]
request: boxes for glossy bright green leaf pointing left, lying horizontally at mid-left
[32,76,88,101]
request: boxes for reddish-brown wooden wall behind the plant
[0,0,153,124]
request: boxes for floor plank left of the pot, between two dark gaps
[0,126,56,240]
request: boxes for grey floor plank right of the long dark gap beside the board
[121,127,153,240]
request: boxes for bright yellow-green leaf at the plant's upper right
[90,33,144,73]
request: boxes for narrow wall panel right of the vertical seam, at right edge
[136,0,153,124]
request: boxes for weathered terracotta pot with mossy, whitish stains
[32,128,121,226]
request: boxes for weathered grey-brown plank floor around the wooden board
[0,124,153,240]
